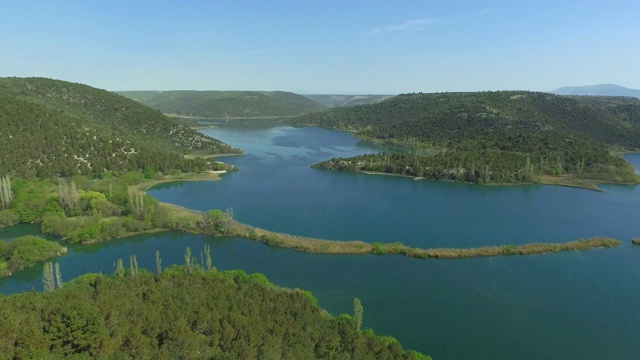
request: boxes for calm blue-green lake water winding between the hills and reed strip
[0,121,640,359]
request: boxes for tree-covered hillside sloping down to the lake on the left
[0,78,238,177]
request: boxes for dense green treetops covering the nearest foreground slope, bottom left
[0,272,428,359]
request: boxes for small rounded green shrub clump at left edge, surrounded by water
[0,235,66,276]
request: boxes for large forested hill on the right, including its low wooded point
[292,91,640,183]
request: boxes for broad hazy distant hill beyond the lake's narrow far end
[118,91,326,118]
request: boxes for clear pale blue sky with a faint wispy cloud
[0,0,640,94]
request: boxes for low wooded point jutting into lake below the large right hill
[313,151,635,184]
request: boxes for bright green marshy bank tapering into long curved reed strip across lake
[0,172,619,258]
